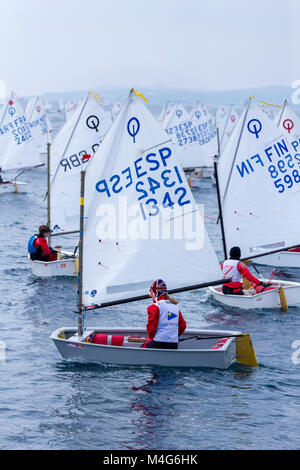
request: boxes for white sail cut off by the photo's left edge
[0,93,43,171]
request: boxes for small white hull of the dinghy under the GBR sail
[29,258,78,277]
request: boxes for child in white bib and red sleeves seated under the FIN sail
[221,246,271,295]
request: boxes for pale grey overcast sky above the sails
[0,0,300,95]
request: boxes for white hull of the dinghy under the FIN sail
[208,280,300,310]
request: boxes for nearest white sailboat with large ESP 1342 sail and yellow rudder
[51,89,257,369]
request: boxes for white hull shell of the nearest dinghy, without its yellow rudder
[50,328,245,369]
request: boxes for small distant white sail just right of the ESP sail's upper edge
[163,103,205,168]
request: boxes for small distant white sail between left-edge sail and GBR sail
[26,96,52,152]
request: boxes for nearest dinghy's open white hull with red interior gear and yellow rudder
[51,328,257,369]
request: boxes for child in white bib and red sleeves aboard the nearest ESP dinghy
[142,279,186,349]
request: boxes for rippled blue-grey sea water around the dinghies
[0,115,300,450]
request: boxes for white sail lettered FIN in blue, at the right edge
[218,99,300,257]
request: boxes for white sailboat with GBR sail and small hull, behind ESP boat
[29,93,111,277]
